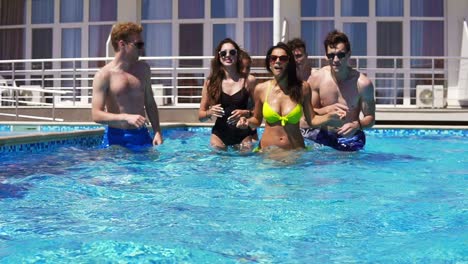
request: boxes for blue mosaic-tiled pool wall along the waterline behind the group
[0,124,468,154]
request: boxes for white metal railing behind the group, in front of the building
[0,56,468,120]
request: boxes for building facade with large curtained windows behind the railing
[0,0,468,106]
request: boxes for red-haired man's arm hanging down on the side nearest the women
[144,65,163,145]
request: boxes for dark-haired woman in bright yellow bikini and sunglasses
[237,42,312,150]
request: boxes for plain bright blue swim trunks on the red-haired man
[104,127,153,147]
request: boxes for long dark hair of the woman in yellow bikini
[265,42,302,103]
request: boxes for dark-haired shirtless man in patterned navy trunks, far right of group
[302,30,375,151]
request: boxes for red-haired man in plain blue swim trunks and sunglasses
[92,22,163,146]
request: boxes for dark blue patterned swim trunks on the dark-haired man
[301,128,366,151]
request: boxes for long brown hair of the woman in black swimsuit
[207,38,241,104]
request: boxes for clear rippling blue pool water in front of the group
[0,128,468,263]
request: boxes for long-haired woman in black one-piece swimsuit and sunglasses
[198,38,255,149]
